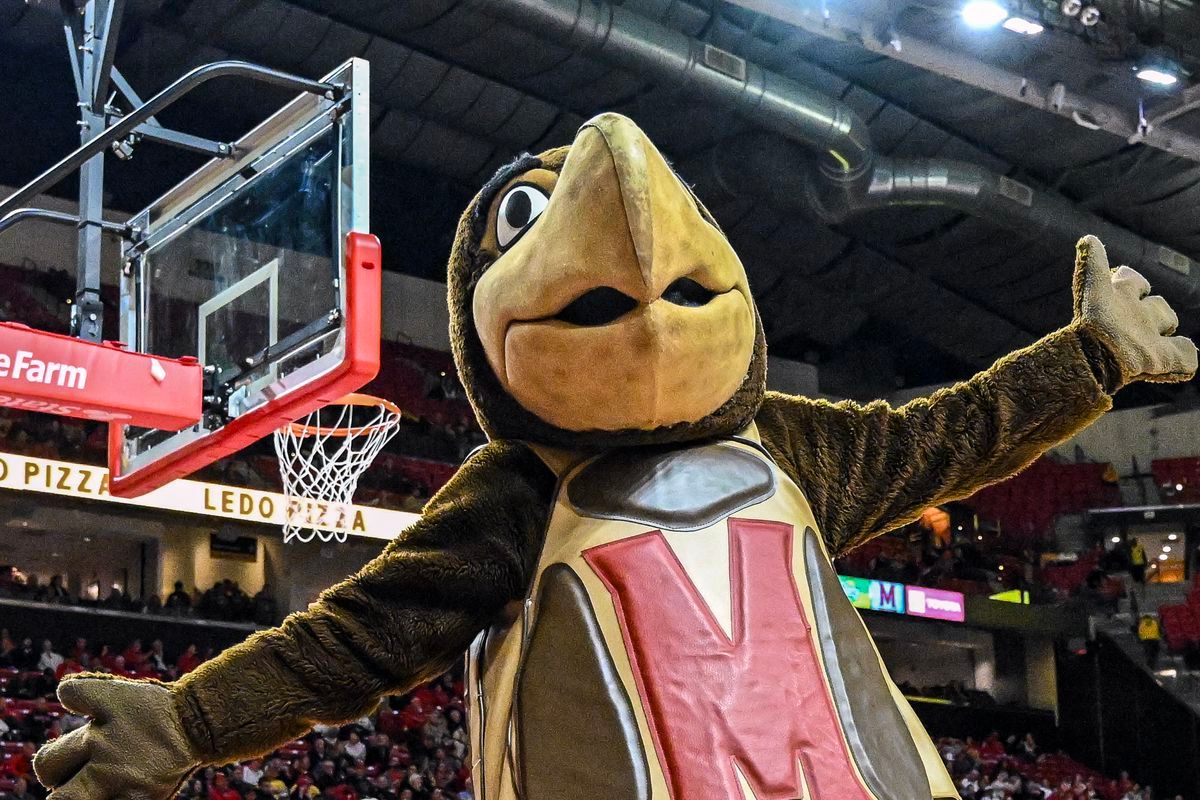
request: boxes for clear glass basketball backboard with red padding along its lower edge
[109,59,382,497]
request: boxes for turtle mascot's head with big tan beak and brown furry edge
[448,114,767,449]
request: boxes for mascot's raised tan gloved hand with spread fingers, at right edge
[1074,236,1196,384]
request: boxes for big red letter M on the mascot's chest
[584,519,870,800]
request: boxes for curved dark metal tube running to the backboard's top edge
[0,61,340,218]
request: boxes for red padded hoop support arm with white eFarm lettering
[0,323,202,431]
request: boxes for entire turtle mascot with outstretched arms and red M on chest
[35,114,1196,800]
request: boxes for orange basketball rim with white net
[275,395,401,542]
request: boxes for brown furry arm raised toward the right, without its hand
[756,324,1121,554]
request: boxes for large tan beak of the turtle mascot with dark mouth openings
[473,114,755,431]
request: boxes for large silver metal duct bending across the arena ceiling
[478,0,1200,308]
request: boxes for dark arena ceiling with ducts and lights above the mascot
[0,0,1200,402]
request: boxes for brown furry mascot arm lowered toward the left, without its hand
[174,443,554,763]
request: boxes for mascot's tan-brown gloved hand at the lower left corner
[34,675,200,800]
